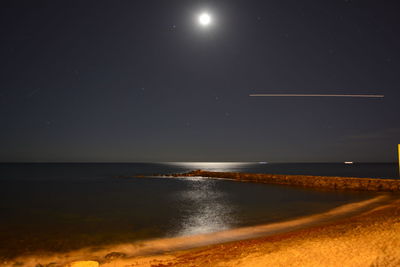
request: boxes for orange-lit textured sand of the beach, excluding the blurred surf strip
[97,196,400,266]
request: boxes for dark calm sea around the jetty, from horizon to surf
[0,163,397,257]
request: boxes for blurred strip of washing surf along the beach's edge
[3,194,396,266]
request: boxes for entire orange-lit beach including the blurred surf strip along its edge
[3,195,400,266]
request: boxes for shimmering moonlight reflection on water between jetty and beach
[175,178,235,236]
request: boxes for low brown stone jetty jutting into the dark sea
[132,170,400,192]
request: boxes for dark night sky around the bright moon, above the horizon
[0,0,400,162]
